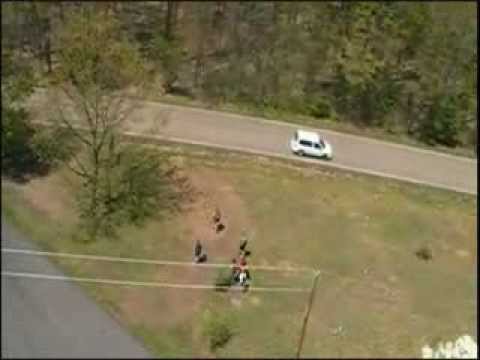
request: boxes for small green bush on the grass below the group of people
[204,311,234,352]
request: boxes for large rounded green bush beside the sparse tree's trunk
[77,145,179,240]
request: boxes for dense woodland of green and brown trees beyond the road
[2,1,477,147]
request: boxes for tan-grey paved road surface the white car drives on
[32,92,477,194]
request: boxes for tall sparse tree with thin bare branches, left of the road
[53,9,150,238]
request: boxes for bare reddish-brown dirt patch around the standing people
[121,167,251,329]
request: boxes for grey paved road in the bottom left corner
[2,219,151,358]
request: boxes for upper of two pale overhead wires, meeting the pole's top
[2,248,314,272]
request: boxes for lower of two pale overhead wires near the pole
[2,271,310,292]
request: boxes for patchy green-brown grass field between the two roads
[2,146,477,357]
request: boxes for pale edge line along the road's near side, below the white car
[31,121,477,195]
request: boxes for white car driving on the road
[290,130,333,160]
